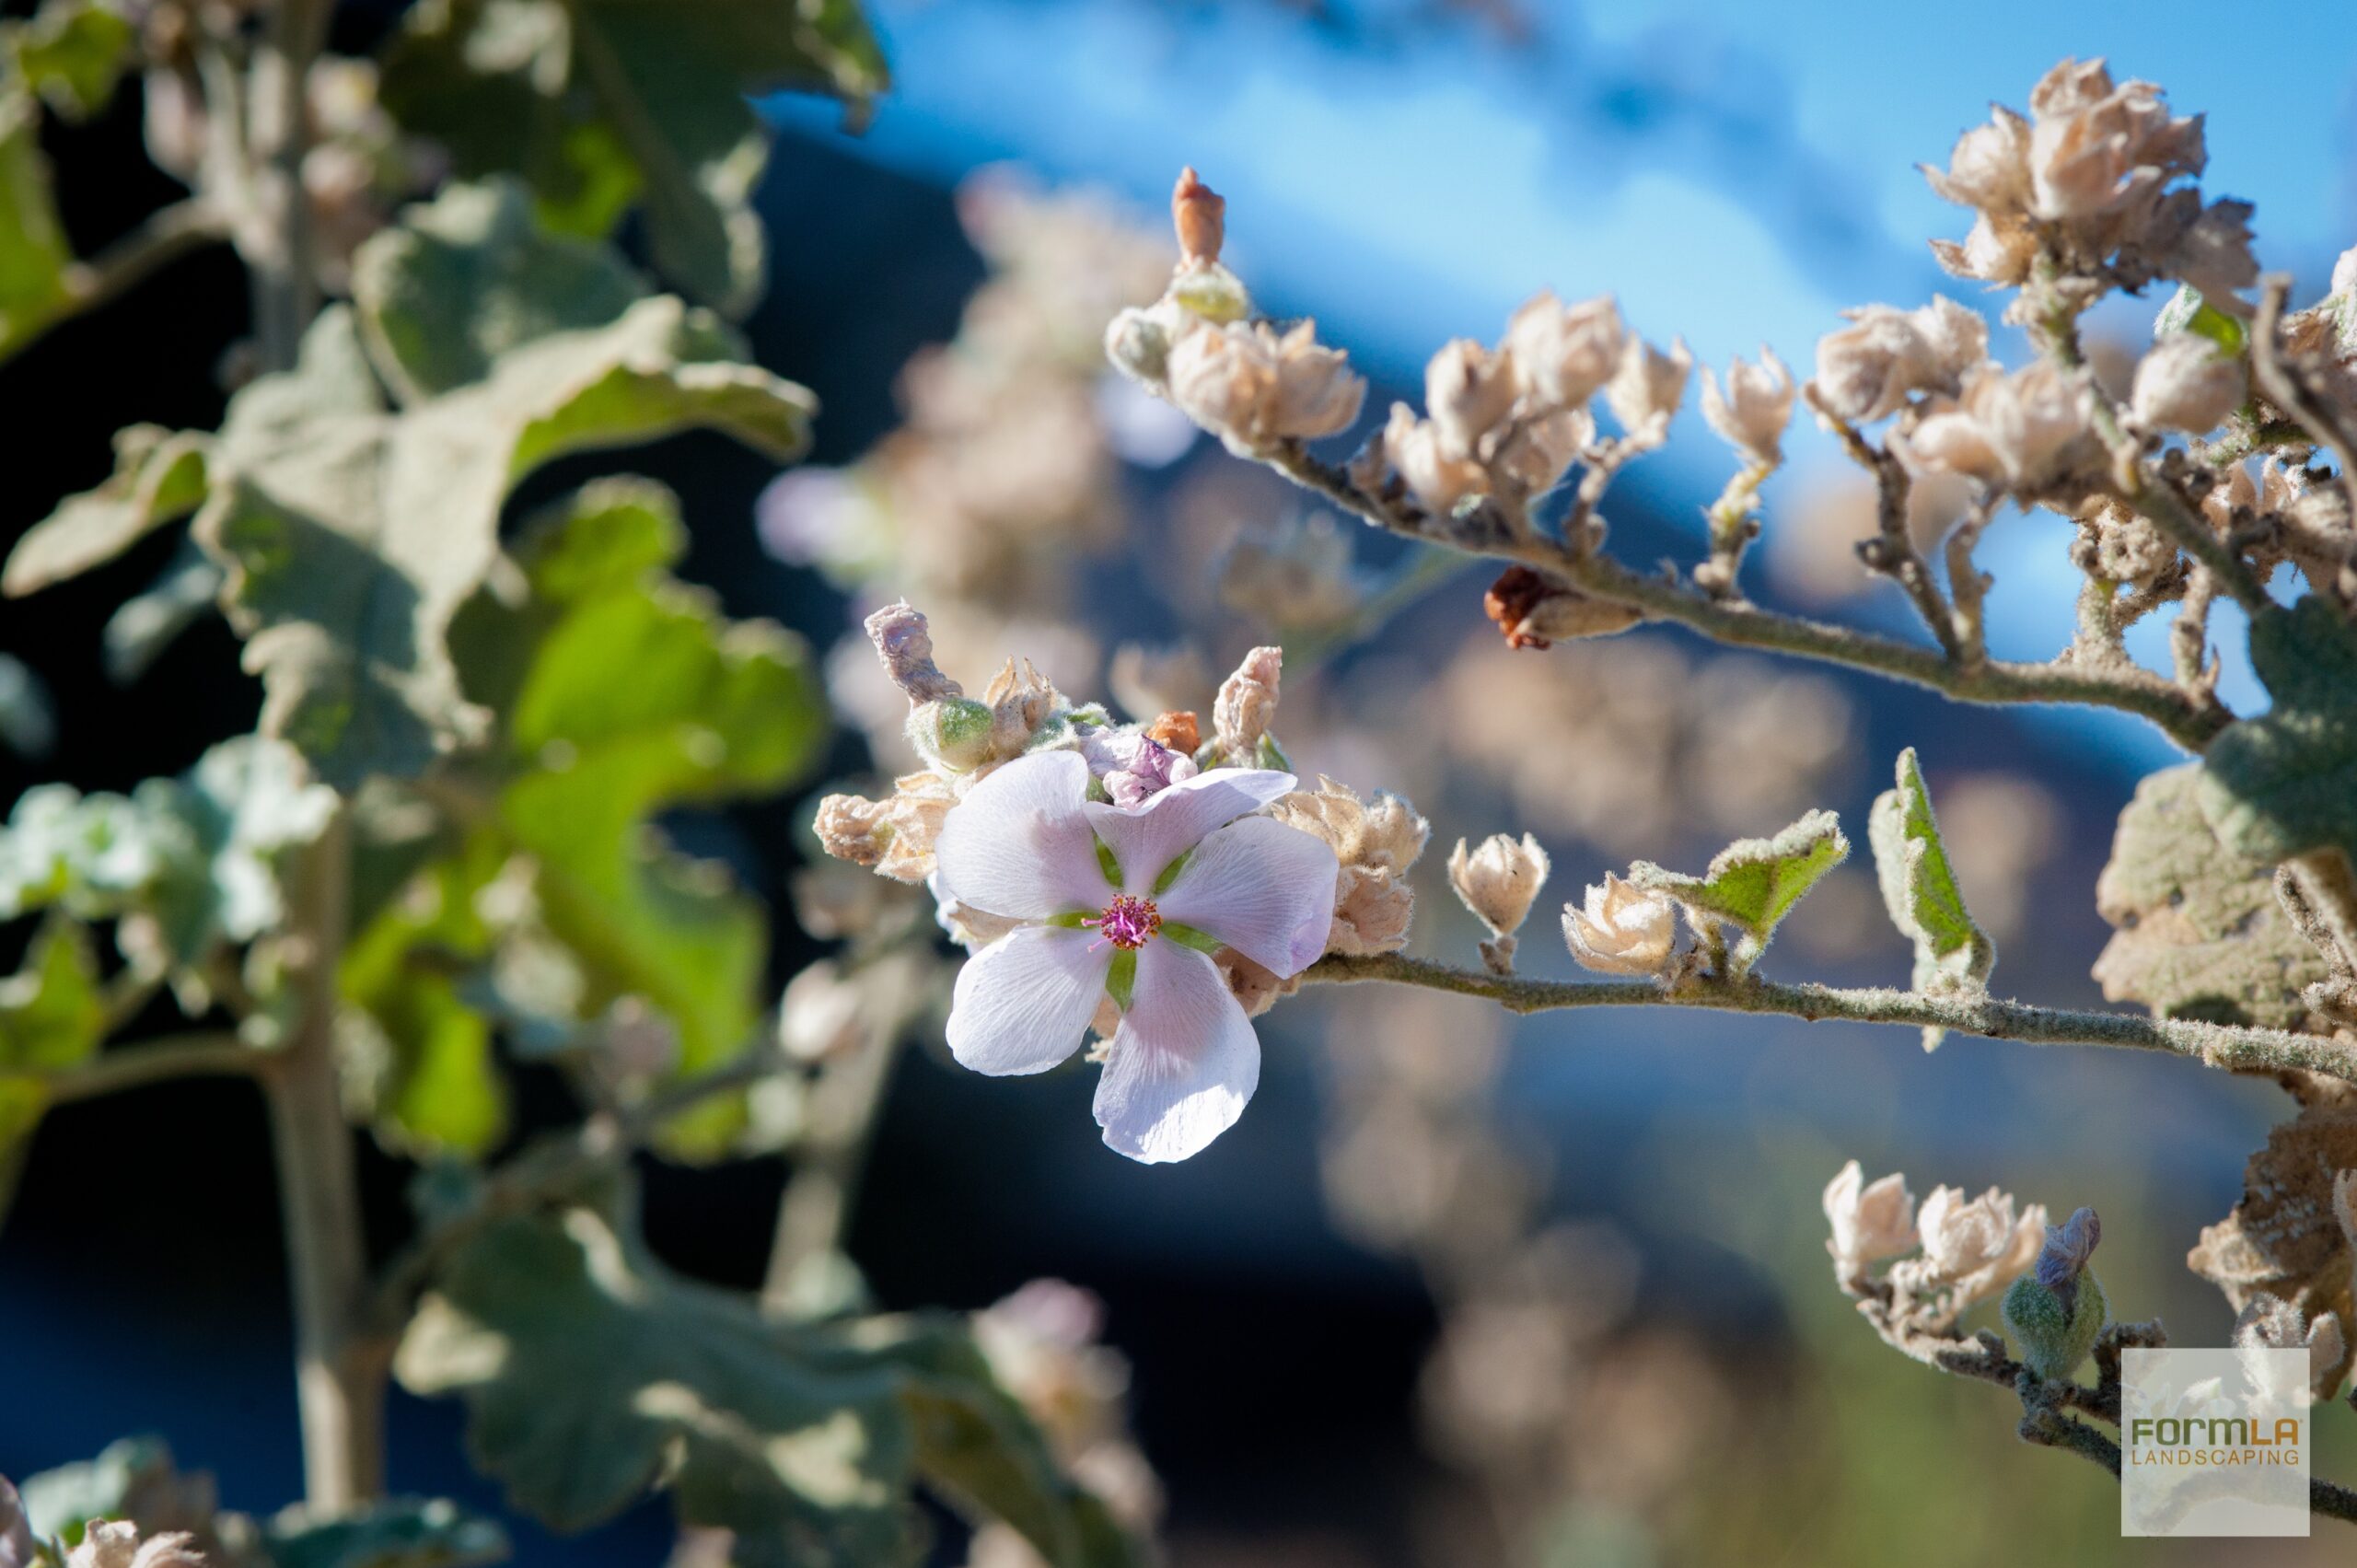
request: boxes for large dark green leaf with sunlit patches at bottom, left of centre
[394,1210,1136,1568]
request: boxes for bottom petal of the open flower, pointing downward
[1096,941,1261,1165]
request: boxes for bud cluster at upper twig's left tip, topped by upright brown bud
[1106,169,1367,458]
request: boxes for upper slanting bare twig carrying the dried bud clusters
[1266,443,2230,752]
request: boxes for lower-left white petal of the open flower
[950,926,1112,1077]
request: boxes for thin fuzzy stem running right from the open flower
[1304,953,2357,1082]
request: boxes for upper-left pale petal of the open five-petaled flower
[934,752,1112,920]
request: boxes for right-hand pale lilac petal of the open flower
[1155,816,1341,979]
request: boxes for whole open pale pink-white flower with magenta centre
[935,752,1341,1163]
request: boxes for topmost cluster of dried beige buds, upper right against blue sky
[1923,59,2258,314]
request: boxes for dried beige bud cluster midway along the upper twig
[1364,293,1695,514]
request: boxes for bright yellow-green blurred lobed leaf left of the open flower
[389,481,828,1156]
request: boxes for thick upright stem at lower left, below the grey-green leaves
[261,811,389,1514]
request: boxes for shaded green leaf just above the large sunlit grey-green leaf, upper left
[351,180,648,403]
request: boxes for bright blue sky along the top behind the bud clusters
[778,0,2357,760]
